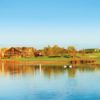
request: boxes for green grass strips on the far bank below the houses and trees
[2,53,100,64]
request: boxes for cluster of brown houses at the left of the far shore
[0,47,42,58]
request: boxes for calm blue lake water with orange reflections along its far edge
[0,63,100,100]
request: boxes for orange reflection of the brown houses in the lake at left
[0,62,39,75]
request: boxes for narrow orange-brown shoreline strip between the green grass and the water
[0,59,100,66]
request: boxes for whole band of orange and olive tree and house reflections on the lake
[0,62,100,78]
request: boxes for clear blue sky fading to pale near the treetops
[0,0,100,48]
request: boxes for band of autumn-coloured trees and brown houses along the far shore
[0,45,100,58]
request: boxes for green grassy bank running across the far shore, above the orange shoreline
[1,53,100,64]
